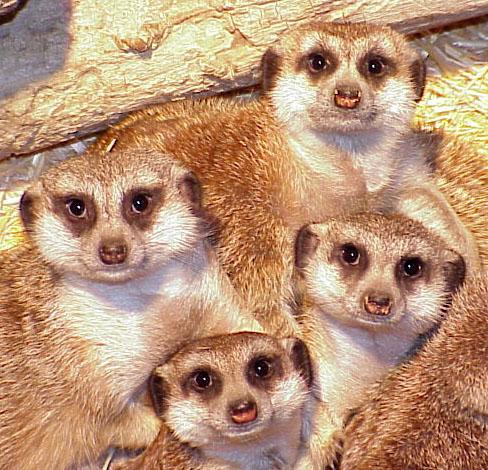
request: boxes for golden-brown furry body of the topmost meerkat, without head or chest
[88,98,303,335]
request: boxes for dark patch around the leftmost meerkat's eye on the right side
[122,187,163,230]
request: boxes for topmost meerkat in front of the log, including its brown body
[88,23,482,335]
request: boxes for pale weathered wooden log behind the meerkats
[0,0,488,158]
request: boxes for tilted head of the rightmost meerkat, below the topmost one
[295,213,465,333]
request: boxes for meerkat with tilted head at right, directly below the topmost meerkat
[296,213,465,468]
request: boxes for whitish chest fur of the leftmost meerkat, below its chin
[57,264,204,391]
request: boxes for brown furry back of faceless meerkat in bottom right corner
[341,275,488,470]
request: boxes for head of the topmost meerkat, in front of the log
[262,23,425,148]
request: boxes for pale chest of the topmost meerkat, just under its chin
[287,132,412,221]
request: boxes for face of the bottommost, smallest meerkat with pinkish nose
[150,333,311,447]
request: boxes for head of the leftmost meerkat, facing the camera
[20,149,205,283]
